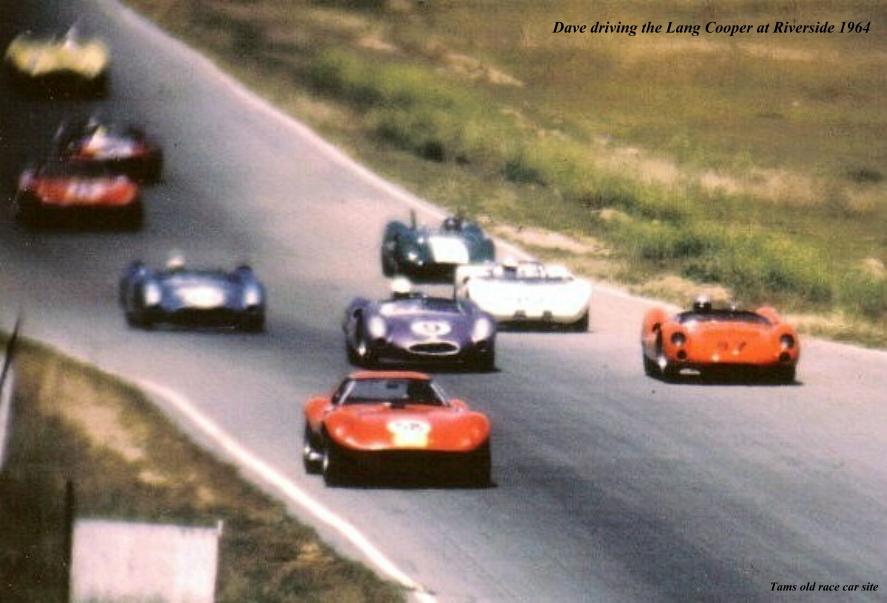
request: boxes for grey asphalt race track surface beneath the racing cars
[0,0,887,601]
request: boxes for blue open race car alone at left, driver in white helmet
[119,256,266,332]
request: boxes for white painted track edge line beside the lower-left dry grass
[136,379,436,603]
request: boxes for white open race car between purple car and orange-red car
[454,260,591,332]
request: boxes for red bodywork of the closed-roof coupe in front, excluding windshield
[304,371,490,482]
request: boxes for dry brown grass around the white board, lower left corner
[0,343,403,603]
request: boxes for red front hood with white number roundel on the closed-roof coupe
[324,404,490,452]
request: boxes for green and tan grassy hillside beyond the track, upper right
[131,0,887,345]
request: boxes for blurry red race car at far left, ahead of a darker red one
[13,158,143,229]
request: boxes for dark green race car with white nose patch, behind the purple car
[382,212,496,282]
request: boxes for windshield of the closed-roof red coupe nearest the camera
[333,377,449,407]
